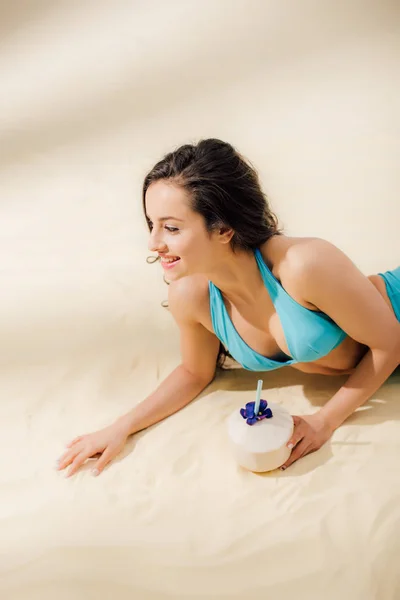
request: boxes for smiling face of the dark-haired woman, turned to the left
[145,180,222,281]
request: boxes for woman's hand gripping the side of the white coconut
[280,412,334,470]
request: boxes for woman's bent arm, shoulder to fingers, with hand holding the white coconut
[285,240,400,466]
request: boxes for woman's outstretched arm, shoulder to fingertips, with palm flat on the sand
[57,277,219,476]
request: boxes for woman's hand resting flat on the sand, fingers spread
[57,421,129,477]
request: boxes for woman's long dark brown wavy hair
[142,138,282,368]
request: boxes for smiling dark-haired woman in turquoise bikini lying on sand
[58,139,400,476]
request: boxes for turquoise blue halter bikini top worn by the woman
[208,249,346,371]
